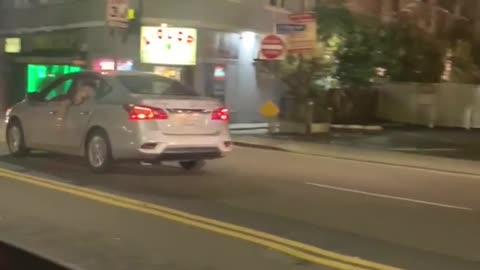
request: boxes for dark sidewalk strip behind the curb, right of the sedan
[232,126,480,161]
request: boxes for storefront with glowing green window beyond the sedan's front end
[4,29,87,105]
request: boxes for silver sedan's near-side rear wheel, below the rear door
[85,131,113,173]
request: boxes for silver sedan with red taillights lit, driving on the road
[6,72,232,172]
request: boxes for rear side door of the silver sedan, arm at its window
[59,75,107,155]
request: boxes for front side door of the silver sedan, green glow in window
[26,76,74,151]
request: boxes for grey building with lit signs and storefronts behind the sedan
[0,0,304,122]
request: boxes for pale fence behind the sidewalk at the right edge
[377,83,480,128]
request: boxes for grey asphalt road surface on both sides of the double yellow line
[0,148,480,270]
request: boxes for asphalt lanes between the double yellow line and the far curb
[0,144,480,270]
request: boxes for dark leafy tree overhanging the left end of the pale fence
[316,2,445,122]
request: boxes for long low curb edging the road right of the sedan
[233,141,480,177]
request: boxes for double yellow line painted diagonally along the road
[0,168,399,270]
